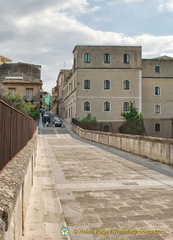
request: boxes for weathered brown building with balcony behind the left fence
[0,63,42,106]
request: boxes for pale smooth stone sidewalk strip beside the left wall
[22,127,70,240]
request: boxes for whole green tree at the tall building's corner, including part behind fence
[119,102,146,135]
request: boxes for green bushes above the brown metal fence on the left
[3,93,39,120]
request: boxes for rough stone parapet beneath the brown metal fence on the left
[0,132,37,240]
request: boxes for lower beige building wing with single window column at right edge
[142,56,173,137]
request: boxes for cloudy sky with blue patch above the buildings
[0,0,173,92]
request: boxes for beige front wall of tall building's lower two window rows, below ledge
[76,69,140,121]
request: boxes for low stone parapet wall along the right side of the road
[73,124,173,166]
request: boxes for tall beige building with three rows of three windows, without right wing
[58,46,142,121]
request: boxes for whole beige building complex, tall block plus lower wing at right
[57,46,173,136]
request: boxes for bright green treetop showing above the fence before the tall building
[121,102,143,121]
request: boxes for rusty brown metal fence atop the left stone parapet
[0,99,36,171]
